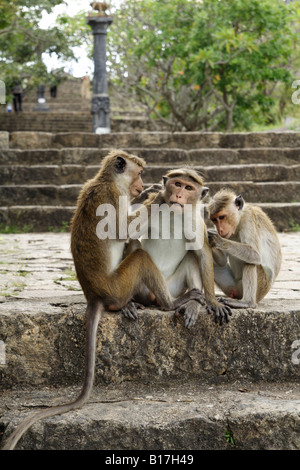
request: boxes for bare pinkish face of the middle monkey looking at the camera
[166,177,199,209]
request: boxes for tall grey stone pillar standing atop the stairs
[87,16,113,134]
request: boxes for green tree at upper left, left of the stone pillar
[0,0,88,100]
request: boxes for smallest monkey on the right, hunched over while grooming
[208,189,281,308]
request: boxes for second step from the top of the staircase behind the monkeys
[0,148,300,167]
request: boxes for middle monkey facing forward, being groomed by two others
[124,167,231,328]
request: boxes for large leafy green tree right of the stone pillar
[108,0,300,131]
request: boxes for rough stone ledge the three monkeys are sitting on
[0,300,300,388]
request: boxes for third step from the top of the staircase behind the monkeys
[0,163,300,185]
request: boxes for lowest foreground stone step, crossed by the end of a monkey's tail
[0,380,300,450]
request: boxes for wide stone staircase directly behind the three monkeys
[0,132,300,231]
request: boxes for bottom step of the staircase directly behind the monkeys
[0,201,300,232]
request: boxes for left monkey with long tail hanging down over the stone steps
[3,150,201,450]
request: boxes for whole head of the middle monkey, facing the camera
[163,168,208,210]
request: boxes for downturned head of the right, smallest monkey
[208,189,244,238]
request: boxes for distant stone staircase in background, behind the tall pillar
[0,76,153,133]
